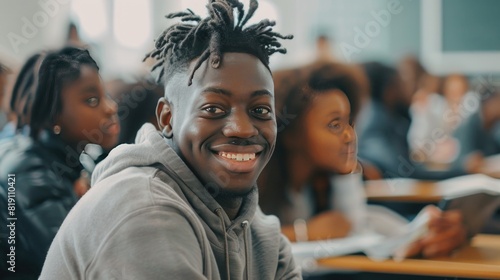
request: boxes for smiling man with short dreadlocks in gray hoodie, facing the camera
[40,0,300,280]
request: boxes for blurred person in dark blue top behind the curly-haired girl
[356,62,472,180]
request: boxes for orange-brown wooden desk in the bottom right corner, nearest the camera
[318,235,500,279]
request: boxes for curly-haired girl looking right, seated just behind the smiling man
[258,64,465,257]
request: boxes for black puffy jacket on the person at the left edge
[0,132,83,279]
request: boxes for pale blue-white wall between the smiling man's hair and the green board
[272,0,421,69]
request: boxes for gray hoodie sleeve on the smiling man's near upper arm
[85,206,207,279]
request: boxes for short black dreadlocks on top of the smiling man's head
[144,0,293,85]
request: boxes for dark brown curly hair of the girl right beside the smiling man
[258,63,365,217]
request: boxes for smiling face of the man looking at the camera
[162,53,276,196]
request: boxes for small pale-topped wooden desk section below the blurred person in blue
[365,179,442,203]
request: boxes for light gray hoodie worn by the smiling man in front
[40,124,301,280]
